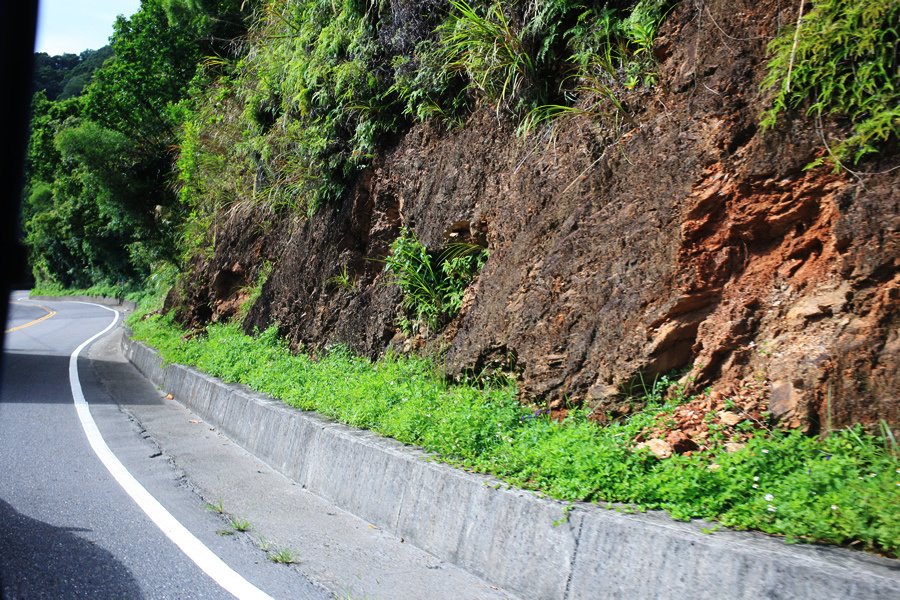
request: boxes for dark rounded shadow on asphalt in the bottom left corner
[0,500,142,600]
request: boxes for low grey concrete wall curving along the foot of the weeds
[123,336,900,600]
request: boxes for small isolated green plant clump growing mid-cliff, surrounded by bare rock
[385,229,488,332]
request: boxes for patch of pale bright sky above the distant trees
[35,0,141,56]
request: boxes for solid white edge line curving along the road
[69,302,272,600]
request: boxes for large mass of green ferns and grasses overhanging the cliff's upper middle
[176,0,671,225]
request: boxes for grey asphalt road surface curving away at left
[0,293,331,600]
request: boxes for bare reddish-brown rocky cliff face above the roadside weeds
[172,0,900,432]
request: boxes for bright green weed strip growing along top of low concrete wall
[129,312,900,557]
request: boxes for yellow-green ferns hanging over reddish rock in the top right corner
[762,0,900,169]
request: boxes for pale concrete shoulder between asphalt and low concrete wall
[88,329,511,600]
